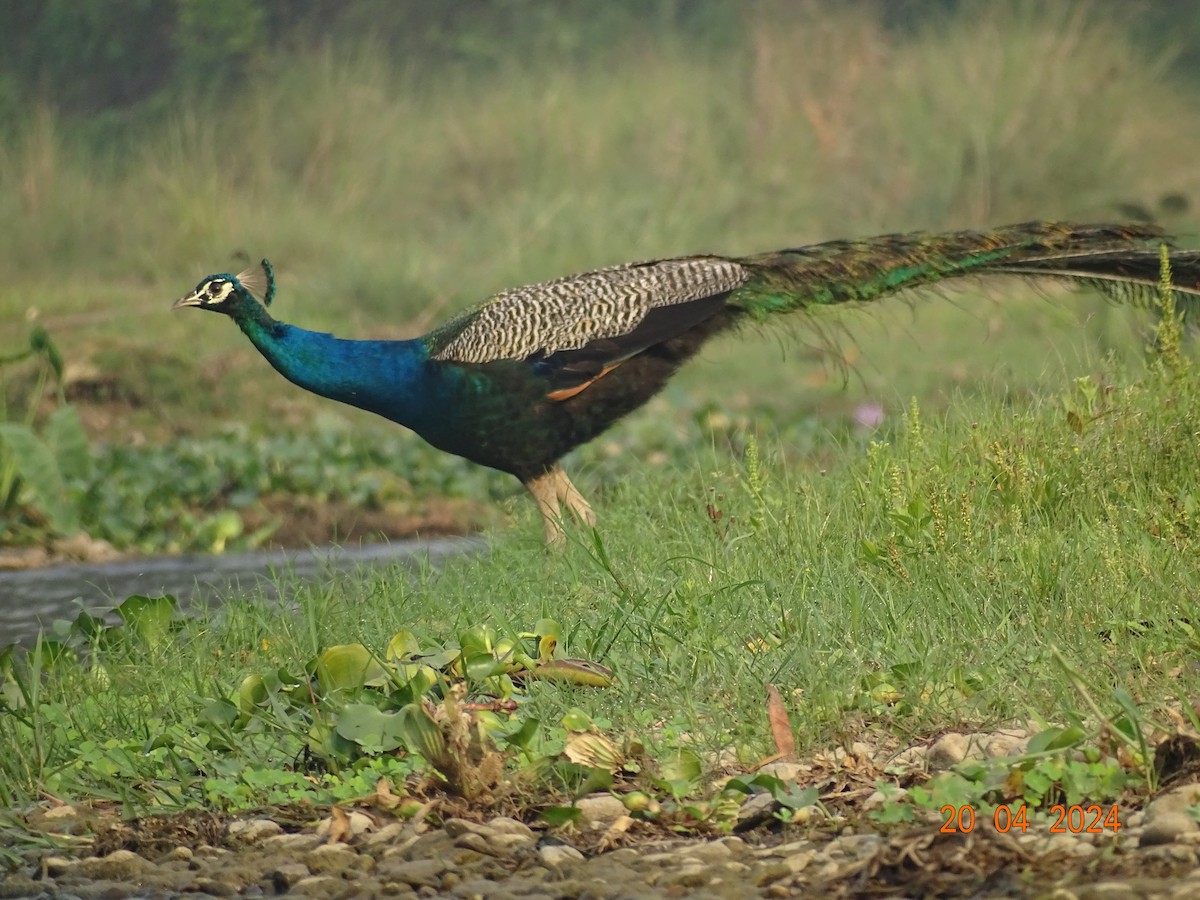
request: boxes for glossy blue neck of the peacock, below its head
[234,304,443,428]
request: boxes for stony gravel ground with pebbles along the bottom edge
[9,732,1200,900]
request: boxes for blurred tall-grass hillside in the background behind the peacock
[0,0,1200,438]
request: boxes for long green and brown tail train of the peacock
[730,222,1200,319]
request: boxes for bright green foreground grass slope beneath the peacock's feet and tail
[0,328,1200,808]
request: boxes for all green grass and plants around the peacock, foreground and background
[0,4,1200,859]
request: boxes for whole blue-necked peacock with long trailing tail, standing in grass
[174,222,1200,544]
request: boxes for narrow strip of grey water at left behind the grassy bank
[0,538,484,647]
